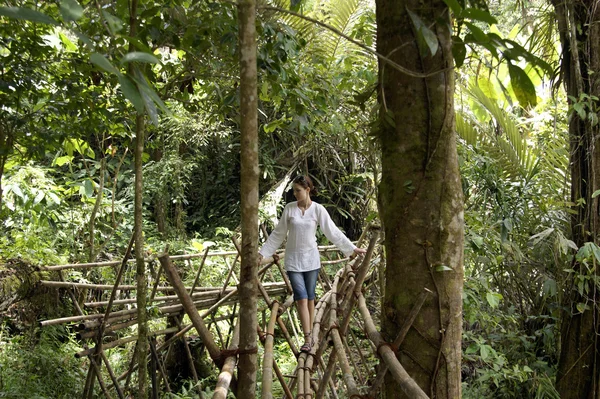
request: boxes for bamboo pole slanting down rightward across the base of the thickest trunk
[358,294,429,399]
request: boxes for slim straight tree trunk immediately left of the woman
[237,0,259,399]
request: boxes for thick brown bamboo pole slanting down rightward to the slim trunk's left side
[158,254,221,360]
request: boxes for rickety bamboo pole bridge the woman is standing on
[40,229,429,399]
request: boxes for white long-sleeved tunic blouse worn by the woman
[259,201,356,272]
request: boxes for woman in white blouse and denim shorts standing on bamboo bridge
[258,176,366,352]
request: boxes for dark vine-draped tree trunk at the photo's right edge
[552,0,600,399]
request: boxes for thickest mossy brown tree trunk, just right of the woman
[376,0,464,398]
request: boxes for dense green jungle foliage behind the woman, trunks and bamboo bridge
[0,0,600,398]
